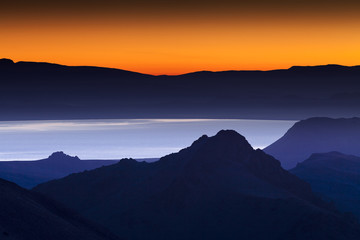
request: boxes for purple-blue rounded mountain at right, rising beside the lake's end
[264,118,360,169]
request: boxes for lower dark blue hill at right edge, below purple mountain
[290,152,360,219]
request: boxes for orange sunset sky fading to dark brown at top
[0,0,360,74]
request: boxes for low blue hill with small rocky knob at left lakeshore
[0,152,118,189]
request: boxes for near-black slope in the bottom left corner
[0,179,118,240]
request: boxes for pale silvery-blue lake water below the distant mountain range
[0,119,295,160]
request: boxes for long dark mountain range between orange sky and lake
[0,59,360,120]
